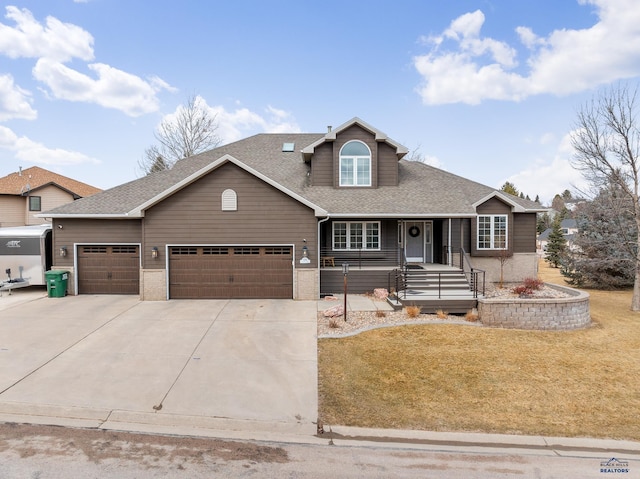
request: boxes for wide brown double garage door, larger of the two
[169,246,293,299]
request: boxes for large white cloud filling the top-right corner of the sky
[414,0,640,104]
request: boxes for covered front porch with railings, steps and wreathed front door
[320,218,484,313]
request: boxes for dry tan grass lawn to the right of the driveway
[319,263,640,440]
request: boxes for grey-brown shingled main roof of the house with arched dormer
[40,133,545,218]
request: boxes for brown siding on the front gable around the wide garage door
[142,163,318,269]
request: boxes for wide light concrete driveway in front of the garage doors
[0,290,318,433]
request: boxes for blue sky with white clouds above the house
[0,0,640,203]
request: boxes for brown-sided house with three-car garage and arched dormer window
[41,118,544,310]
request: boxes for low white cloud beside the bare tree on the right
[502,134,586,205]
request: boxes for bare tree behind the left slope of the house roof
[138,95,221,175]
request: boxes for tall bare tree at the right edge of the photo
[572,85,640,311]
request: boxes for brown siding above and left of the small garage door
[53,219,142,267]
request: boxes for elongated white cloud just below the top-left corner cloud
[33,58,171,117]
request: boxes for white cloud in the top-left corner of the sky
[0,6,93,62]
